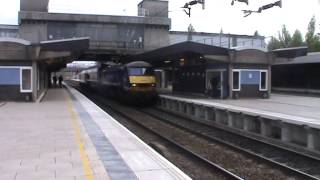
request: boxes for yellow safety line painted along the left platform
[66,94,94,180]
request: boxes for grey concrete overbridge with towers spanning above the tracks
[19,0,171,58]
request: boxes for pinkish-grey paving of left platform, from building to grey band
[0,89,109,180]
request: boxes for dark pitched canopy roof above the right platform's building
[126,41,308,67]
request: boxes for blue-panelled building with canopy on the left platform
[0,38,89,101]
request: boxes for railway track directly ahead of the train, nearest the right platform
[143,109,320,179]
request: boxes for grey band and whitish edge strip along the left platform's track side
[70,88,190,180]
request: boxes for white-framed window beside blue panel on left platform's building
[20,67,32,92]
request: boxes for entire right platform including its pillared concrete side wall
[159,94,320,154]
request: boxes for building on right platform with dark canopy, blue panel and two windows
[133,41,306,99]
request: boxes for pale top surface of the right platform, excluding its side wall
[161,94,320,128]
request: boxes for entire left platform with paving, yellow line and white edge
[0,88,190,180]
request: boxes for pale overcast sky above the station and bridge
[0,0,320,36]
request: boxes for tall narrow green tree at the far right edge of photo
[306,16,320,52]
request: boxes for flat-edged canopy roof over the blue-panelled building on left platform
[0,37,89,71]
